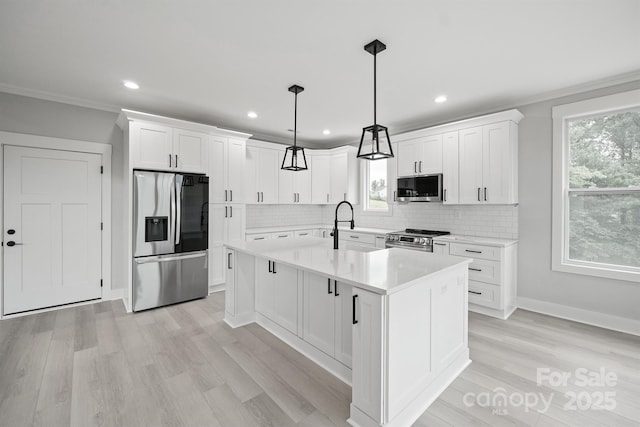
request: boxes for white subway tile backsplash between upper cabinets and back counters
[247,203,518,239]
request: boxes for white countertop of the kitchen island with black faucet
[226,237,471,295]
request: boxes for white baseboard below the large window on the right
[518,297,640,336]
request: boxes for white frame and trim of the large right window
[551,90,640,283]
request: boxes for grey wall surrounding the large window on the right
[518,81,640,330]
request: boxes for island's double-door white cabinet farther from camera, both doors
[255,258,298,334]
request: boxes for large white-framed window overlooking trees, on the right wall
[553,91,640,282]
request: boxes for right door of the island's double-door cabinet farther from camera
[274,263,298,335]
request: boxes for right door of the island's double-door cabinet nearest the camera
[332,281,353,367]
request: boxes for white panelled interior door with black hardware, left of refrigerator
[3,146,102,314]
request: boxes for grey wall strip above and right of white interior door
[0,92,126,289]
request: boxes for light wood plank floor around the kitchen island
[0,293,640,427]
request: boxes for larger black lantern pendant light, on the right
[358,39,393,160]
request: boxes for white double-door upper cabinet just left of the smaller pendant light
[245,144,280,204]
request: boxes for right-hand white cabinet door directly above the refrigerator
[173,129,209,173]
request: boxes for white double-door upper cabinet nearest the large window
[459,121,518,204]
